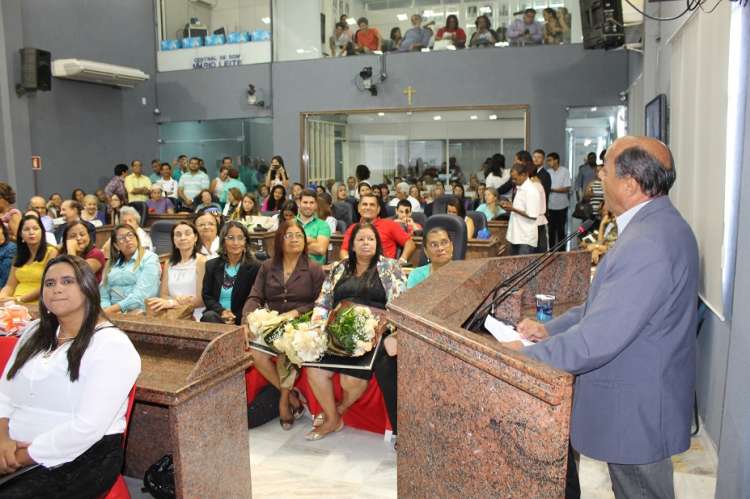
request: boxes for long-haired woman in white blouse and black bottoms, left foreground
[0,255,141,499]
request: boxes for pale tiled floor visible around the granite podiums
[128,417,716,499]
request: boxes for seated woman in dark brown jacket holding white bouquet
[242,220,325,430]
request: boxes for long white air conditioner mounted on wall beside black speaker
[52,59,149,88]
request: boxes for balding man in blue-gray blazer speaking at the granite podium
[509,137,698,499]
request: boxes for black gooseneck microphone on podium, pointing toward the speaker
[463,218,596,332]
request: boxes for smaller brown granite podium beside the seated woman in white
[112,315,252,499]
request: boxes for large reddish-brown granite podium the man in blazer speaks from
[388,252,591,499]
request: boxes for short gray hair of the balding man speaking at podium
[615,146,677,197]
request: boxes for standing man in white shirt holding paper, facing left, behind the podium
[500,163,542,256]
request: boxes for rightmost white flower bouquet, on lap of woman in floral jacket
[326,305,379,357]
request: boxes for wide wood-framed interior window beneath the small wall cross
[303,106,527,190]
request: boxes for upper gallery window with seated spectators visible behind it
[273,0,582,61]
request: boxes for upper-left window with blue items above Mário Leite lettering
[156,0,271,71]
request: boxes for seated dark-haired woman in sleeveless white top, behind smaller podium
[148,221,206,321]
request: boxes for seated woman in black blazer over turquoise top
[199,220,260,325]
